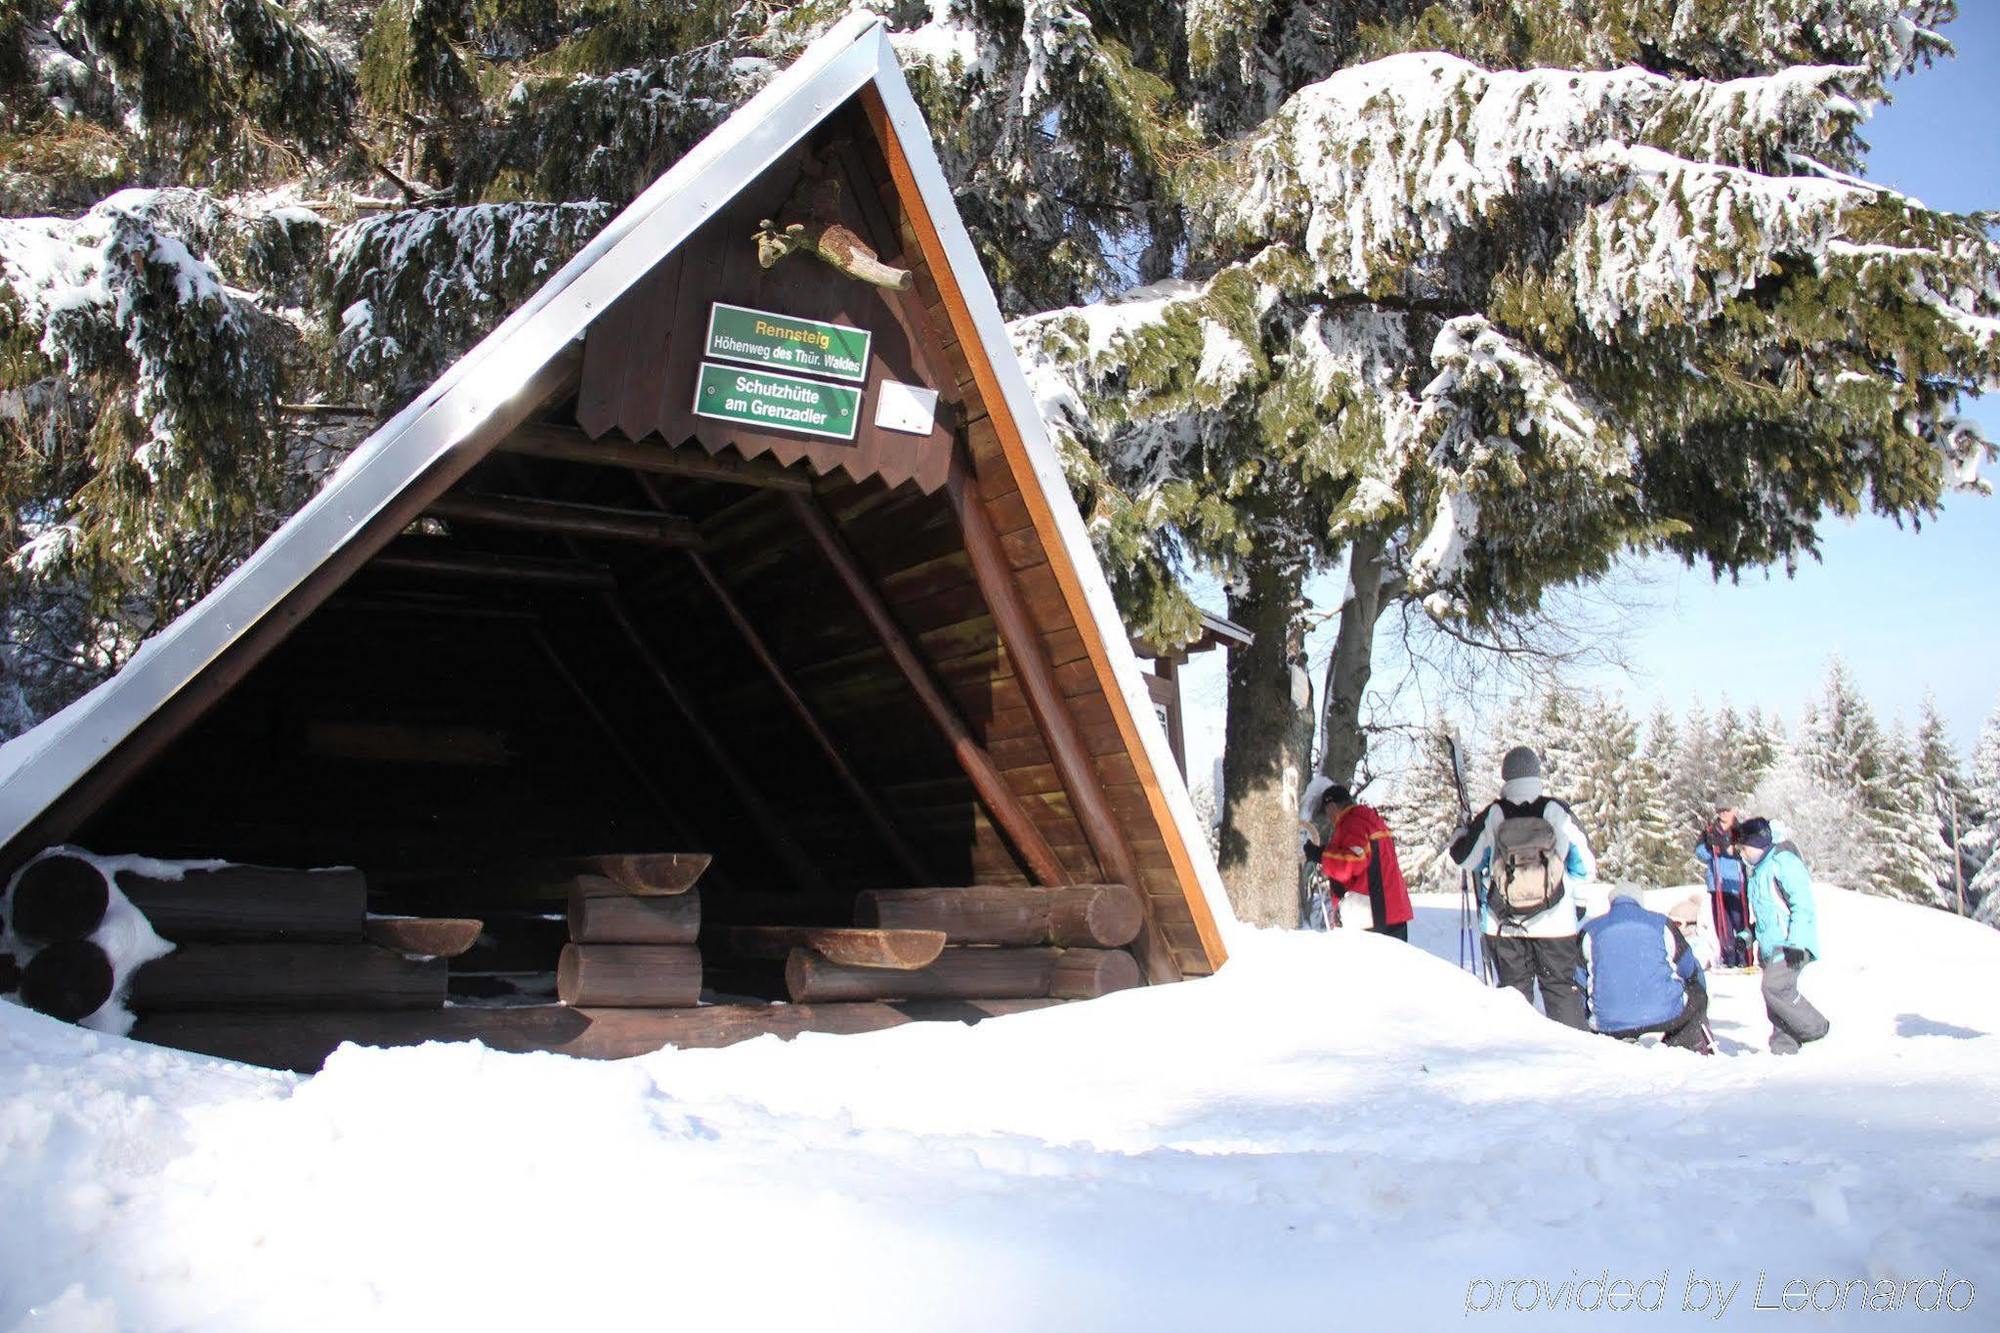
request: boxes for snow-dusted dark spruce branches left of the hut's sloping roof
[0,0,812,735]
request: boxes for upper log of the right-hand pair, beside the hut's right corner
[854,885,1144,949]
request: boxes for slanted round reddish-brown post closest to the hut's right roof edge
[944,462,1180,983]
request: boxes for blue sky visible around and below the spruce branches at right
[1184,0,2000,779]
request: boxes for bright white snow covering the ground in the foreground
[0,876,2000,1333]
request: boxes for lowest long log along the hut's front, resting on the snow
[132,999,1062,1073]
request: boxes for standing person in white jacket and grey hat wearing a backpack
[1450,745,1598,1031]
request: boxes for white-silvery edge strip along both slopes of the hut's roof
[0,12,1234,956]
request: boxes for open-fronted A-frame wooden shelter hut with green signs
[0,16,1226,1069]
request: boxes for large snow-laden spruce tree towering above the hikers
[1000,0,2000,901]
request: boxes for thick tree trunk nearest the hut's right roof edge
[1220,556,1312,927]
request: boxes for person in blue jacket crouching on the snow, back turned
[1582,889,1710,1055]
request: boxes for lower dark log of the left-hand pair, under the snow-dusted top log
[130,943,446,1013]
